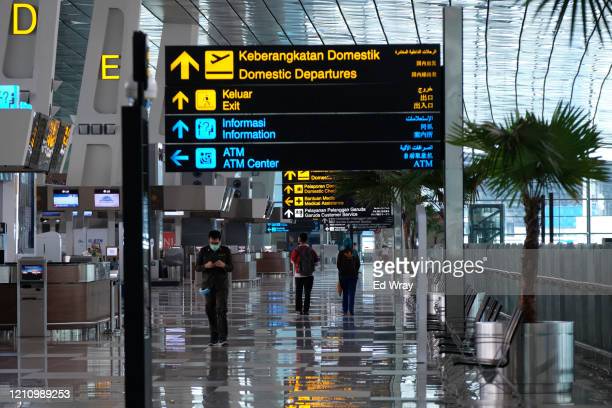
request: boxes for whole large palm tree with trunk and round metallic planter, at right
[449,103,608,392]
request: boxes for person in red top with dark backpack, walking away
[291,232,319,315]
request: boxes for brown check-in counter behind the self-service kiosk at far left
[0,262,119,330]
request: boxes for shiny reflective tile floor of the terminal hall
[0,271,612,408]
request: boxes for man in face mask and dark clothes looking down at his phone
[196,230,233,346]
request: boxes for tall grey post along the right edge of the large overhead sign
[444,7,464,321]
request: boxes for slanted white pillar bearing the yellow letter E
[68,0,140,186]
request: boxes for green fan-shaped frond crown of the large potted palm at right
[450,103,609,204]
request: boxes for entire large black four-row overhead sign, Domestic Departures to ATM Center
[165,45,443,172]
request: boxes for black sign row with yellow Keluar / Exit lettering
[166,79,442,114]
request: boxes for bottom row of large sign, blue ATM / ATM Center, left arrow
[166,142,442,172]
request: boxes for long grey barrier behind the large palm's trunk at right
[464,245,612,355]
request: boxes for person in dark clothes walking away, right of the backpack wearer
[336,238,361,316]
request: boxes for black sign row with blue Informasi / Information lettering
[166,113,442,143]
